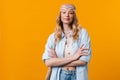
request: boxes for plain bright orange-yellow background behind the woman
[0,0,120,80]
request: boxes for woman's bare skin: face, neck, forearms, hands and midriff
[45,9,88,70]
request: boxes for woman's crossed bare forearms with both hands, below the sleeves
[45,45,88,67]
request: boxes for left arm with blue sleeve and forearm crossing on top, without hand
[42,34,75,67]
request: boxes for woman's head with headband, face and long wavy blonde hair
[55,4,80,42]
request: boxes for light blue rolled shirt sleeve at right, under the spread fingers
[79,28,91,62]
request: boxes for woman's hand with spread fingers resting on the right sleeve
[72,44,89,60]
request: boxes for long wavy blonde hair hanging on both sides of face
[54,6,82,43]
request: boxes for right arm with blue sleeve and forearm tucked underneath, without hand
[64,29,91,66]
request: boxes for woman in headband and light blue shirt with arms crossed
[42,4,91,80]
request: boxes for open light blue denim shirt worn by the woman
[42,28,91,80]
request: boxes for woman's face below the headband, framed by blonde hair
[61,9,74,24]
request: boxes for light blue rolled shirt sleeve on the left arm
[42,33,55,61]
